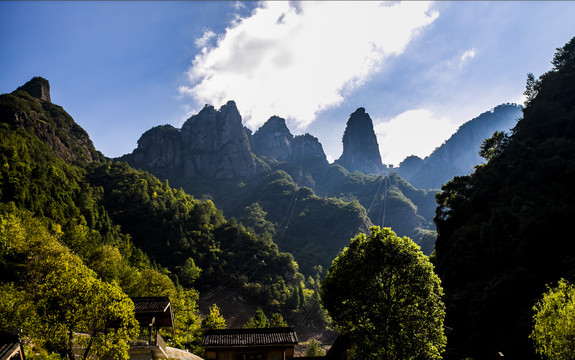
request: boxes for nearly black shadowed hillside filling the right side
[434,38,575,359]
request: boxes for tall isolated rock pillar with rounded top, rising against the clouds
[335,108,385,174]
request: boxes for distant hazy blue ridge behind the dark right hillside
[397,104,522,189]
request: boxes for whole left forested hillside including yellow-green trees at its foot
[0,78,325,356]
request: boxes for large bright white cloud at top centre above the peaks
[180,1,438,130]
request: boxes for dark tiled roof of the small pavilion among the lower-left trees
[132,296,174,327]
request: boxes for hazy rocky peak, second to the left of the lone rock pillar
[251,116,293,161]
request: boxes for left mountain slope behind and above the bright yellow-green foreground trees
[0,80,322,326]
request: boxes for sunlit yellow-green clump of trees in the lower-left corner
[0,212,139,359]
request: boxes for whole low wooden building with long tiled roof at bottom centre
[202,327,298,360]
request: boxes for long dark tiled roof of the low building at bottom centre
[202,327,298,348]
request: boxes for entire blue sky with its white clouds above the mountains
[0,1,575,166]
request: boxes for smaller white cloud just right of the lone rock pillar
[374,109,459,166]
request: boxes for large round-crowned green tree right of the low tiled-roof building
[321,227,446,359]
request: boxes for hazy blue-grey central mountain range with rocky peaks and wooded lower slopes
[120,101,436,276]
